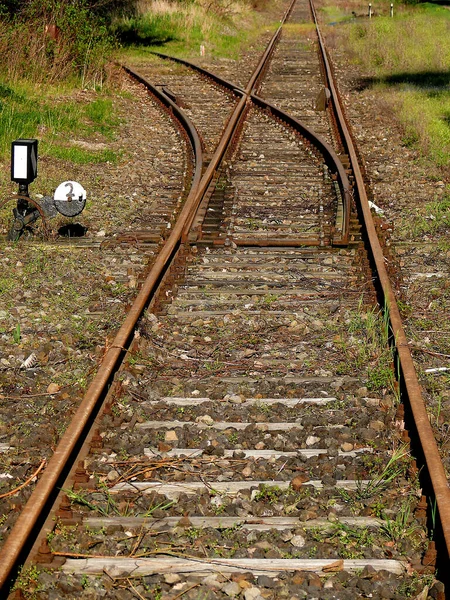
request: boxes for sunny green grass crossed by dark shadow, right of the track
[326,3,450,168]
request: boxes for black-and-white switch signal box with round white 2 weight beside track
[5,139,86,240]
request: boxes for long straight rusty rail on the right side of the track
[310,0,450,560]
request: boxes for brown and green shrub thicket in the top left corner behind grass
[0,0,128,86]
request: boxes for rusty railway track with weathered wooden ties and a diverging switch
[0,1,448,600]
